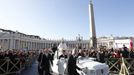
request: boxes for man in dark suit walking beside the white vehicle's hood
[67,50,81,75]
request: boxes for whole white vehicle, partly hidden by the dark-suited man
[52,42,109,75]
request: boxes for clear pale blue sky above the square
[0,0,134,40]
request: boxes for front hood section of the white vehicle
[77,58,109,75]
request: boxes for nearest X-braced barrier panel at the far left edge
[0,58,22,75]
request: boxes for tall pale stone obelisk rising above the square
[89,0,97,49]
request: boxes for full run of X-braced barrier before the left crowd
[0,57,33,75]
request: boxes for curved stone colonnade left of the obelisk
[0,29,90,50]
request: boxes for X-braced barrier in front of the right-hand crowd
[106,58,134,75]
